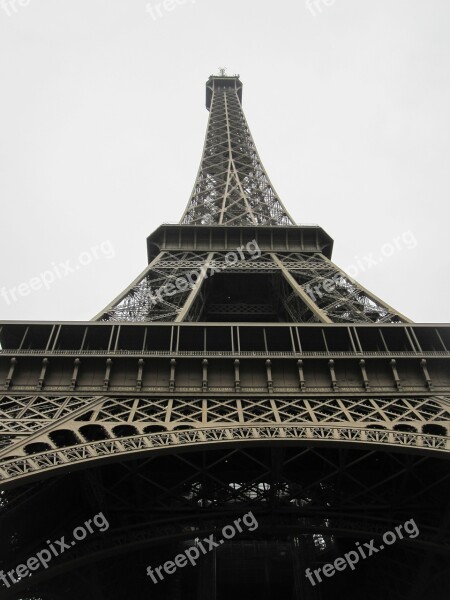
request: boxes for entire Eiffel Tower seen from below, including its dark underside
[0,71,450,600]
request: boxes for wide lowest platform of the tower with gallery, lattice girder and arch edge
[0,323,450,482]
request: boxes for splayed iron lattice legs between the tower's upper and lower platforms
[96,250,409,323]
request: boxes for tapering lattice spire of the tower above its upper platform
[181,73,295,226]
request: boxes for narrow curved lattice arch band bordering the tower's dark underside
[0,422,450,484]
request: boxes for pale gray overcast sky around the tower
[0,0,450,322]
